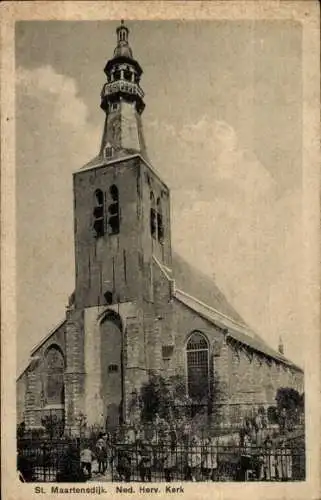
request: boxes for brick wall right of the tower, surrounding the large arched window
[146,264,303,422]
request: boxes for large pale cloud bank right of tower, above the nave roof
[147,117,302,360]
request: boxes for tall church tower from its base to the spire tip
[66,22,171,425]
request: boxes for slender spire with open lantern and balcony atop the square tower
[100,20,146,160]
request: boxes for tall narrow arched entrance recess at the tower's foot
[100,315,123,429]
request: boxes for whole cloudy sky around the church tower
[15,20,303,372]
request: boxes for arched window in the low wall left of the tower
[44,346,65,404]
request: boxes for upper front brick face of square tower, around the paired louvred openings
[74,159,141,308]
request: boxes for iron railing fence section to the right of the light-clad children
[110,445,305,482]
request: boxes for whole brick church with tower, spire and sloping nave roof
[17,22,303,432]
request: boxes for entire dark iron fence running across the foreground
[18,435,305,482]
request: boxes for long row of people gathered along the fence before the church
[62,419,292,482]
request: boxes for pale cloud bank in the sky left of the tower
[16,66,102,370]
